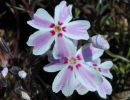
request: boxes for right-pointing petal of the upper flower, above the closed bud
[64,20,90,40]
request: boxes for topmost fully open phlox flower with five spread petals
[27,1,90,58]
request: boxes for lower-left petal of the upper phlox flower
[27,31,54,55]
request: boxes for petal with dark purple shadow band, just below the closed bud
[76,43,104,61]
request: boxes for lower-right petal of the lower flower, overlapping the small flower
[76,64,103,91]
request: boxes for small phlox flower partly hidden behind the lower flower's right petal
[87,59,113,98]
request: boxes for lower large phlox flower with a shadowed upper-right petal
[43,43,104,96]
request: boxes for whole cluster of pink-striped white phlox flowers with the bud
[27,1,113,98]
